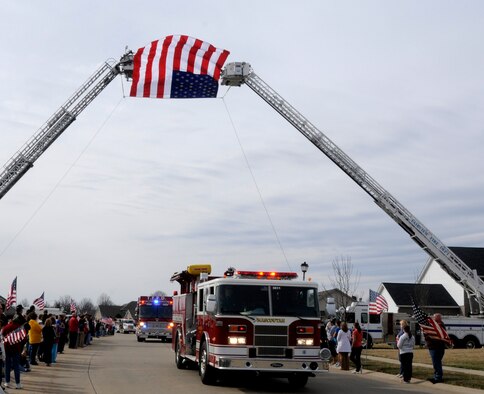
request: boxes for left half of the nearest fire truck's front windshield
[217,285,269,315]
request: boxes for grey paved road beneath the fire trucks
[6,334,482,394]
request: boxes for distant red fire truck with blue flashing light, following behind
[136,296,173,342]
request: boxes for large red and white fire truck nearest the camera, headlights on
[171,265,330,387]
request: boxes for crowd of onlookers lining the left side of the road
[0,305,114,389]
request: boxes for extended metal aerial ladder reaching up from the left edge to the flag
[0,51,133,199]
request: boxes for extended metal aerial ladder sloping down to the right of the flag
[222,62,484,315]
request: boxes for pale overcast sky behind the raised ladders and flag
[0,0,484,304]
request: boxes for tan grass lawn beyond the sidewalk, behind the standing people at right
[361,345,484,371]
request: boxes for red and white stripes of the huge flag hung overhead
[130,35,230,98]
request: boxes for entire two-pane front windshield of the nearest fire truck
[217,285,319,317]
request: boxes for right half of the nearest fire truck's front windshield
[271,286,319,317]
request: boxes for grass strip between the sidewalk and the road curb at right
[361,357,484,390]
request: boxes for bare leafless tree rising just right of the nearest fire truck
[323,256,360,316]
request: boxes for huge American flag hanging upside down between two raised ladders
[130,35,230,98]
